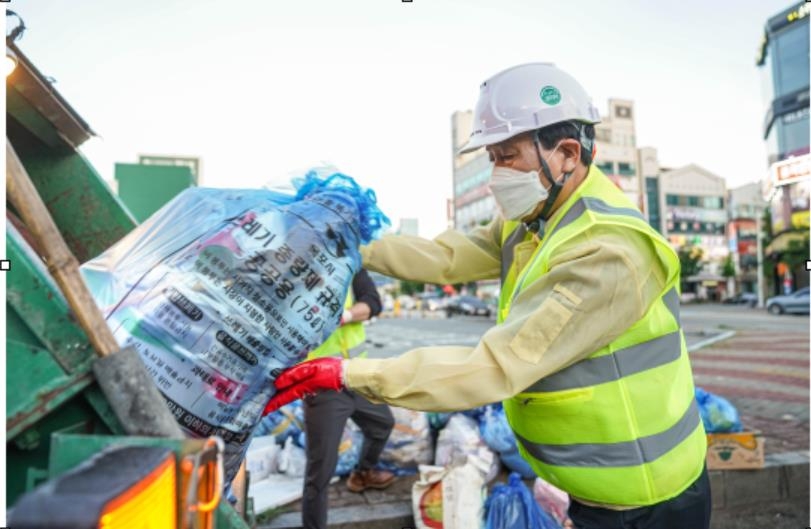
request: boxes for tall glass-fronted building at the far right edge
[756,2,811,293]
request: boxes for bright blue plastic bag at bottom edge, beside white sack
[484,472,561,529]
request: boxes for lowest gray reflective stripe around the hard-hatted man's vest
[515,399,701,467]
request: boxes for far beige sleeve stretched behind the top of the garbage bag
[361,220,503,284]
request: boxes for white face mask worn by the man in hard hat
[488,167,549,220]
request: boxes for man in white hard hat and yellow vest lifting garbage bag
[271,63,711,529]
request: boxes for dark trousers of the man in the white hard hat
[569,468,712,529]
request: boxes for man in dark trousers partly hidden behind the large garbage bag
[301,269,394,529]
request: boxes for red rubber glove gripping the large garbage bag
[262,357,344,416]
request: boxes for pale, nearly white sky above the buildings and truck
[7,0,796,237]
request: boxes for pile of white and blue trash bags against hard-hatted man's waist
[411,403,570,529]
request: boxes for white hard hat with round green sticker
[459,62,600,154]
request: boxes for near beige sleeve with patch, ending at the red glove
[345,225,666,411]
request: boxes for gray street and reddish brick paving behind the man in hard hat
[368,304,809,453]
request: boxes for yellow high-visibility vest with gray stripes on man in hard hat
[499,166,707,506]
